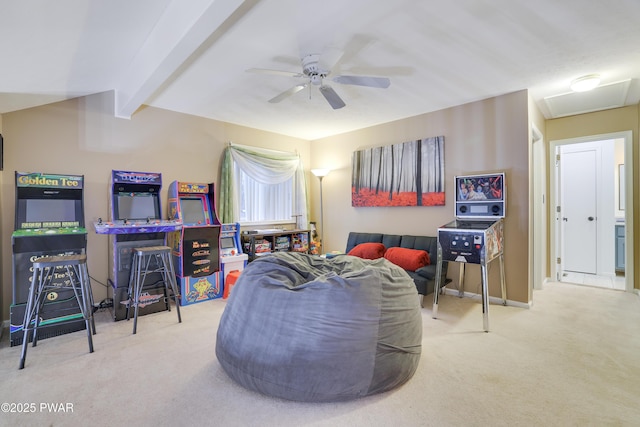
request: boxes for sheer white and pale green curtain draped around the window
[220,143,308,229]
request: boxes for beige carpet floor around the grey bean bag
[0,283,640,427]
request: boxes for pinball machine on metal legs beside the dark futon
[433,173,507,332]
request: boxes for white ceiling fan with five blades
[247,55,391,110]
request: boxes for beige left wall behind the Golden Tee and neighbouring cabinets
[0,93,310,319]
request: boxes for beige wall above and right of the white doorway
[545,105,640,288]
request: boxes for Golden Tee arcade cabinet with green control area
[10,172,87,346]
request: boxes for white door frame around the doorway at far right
[548,131,634,292]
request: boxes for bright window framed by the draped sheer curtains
[234,164,295,223]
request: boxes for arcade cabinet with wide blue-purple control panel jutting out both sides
[94,170,182,320]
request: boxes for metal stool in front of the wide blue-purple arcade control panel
[127,246,182,334]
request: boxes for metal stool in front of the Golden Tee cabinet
[19,254,96,369]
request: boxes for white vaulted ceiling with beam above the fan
[0,0,640,140]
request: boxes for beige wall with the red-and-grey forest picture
[311,91,529,303]
